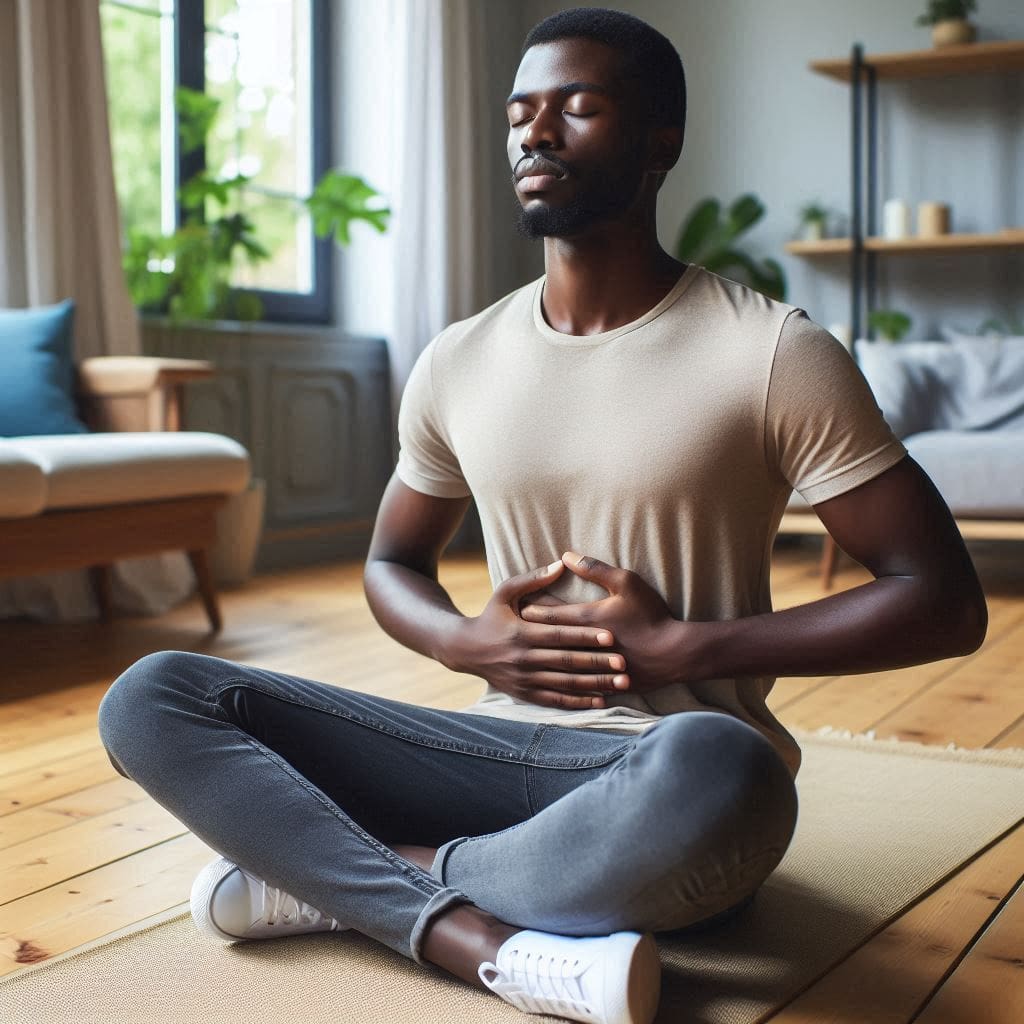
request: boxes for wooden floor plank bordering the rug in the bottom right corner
[769,826,1024,1024]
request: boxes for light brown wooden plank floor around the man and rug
[0,541,1024,1024]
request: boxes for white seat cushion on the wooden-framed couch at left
[3,431,249,509]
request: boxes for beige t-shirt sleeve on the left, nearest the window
[397,339,470,498]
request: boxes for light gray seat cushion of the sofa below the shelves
[903,430,1024,519]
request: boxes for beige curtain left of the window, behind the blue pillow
[0,0,139,359]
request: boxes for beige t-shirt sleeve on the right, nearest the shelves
[765,309,906,505]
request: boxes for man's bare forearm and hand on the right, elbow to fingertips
[521,540,987,692]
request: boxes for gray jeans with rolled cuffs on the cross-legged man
[99,651,797,962]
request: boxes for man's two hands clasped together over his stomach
[452,551,688,709]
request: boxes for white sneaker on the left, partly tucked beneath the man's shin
[189,857,344,942]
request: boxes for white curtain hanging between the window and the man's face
[389,0,494,395]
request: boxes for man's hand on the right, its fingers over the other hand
[519,551,687,692]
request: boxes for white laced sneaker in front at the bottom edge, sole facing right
[479,931,662,1024]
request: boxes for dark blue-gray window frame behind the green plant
[174,0,334,324]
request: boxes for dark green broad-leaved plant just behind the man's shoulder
[676,194,785,301]
